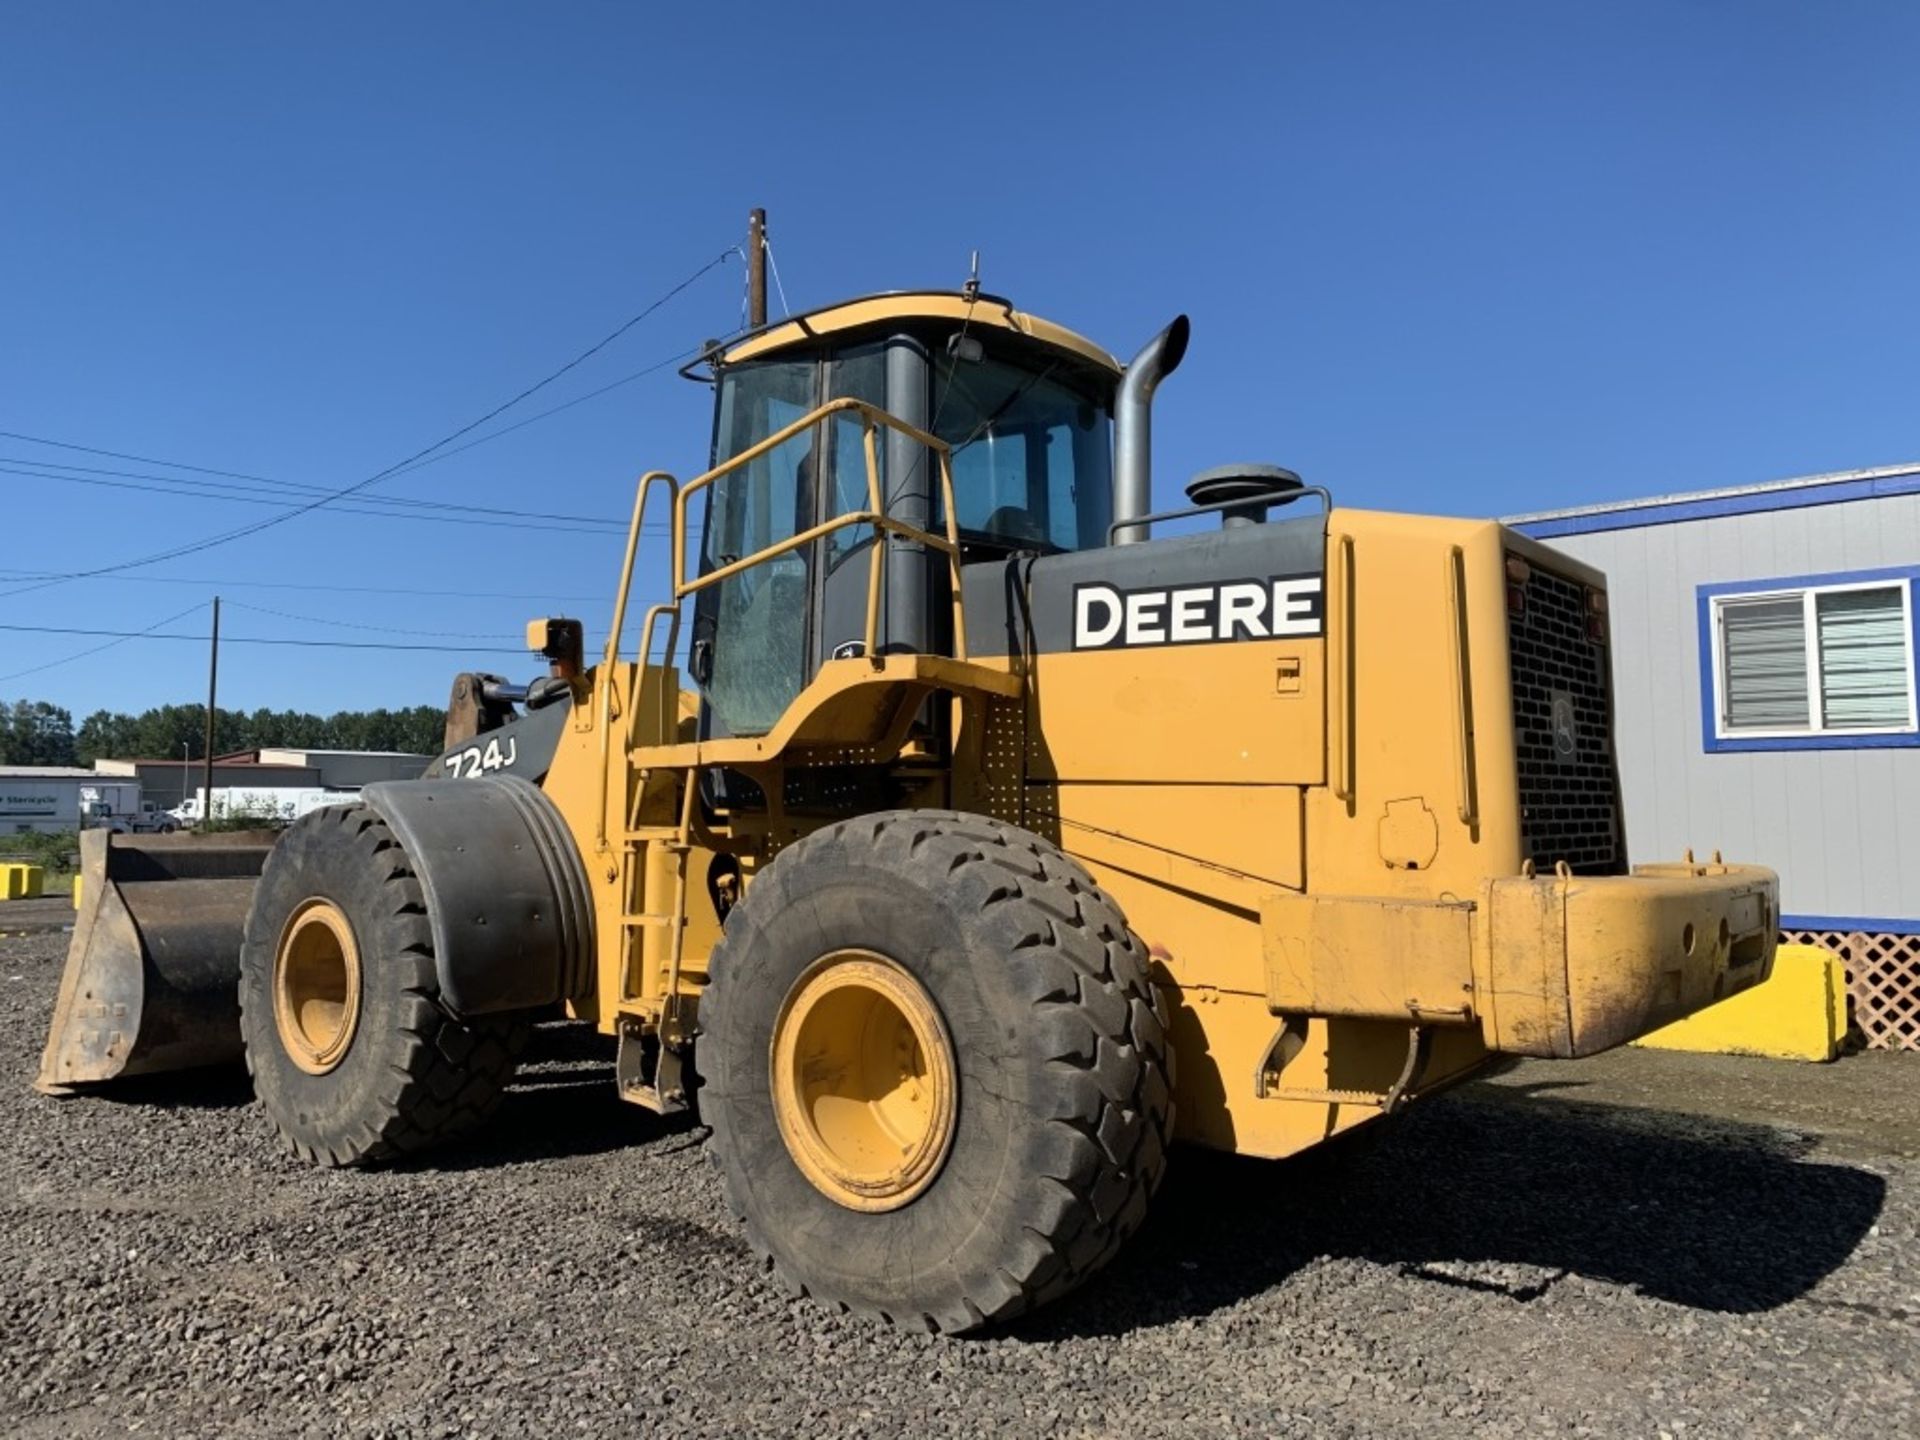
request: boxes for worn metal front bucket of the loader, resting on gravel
[35,829,276,1094]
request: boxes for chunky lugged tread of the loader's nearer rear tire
[708,810,1173,1332]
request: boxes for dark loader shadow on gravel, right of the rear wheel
[1006,1091,1885,1340]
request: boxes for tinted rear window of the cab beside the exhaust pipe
[933,359,1114,549]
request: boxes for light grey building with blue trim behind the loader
[1507,465,1920,939]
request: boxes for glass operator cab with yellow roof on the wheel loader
[687,292,1121,735]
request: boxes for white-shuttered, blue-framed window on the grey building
[1699,570,1920,749]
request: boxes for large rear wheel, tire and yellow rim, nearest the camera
[695,810,1173,1332]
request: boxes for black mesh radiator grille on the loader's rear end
[1507,568,1626,876]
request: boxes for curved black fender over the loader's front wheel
[361,776,593,1016]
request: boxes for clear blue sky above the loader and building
[0,0,1920,718]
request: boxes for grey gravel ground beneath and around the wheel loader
[0,935,1920,1440]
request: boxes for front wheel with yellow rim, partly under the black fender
[240,804,526,1165]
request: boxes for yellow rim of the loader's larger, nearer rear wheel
[772,950,960,1212]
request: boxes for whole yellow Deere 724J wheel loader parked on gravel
[40,288,1778,1331]
